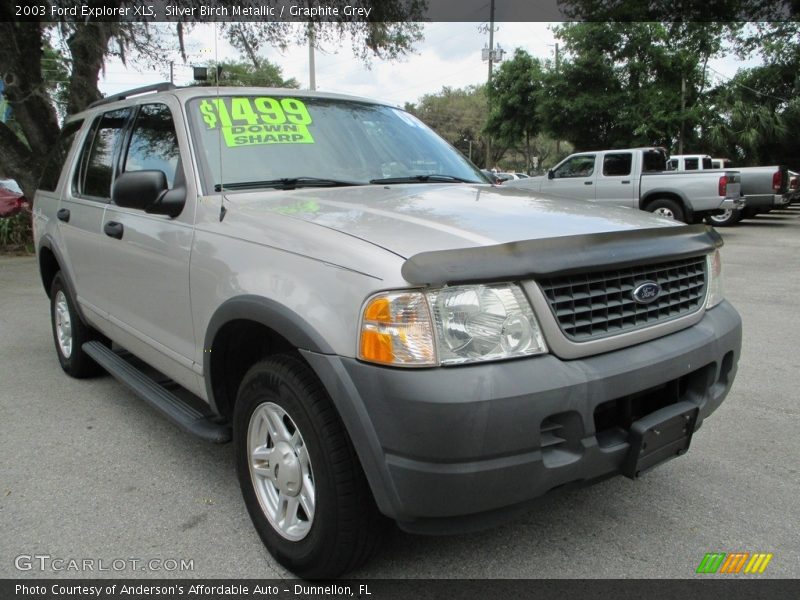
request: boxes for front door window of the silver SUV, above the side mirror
[123,104,180,189]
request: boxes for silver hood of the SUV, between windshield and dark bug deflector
[226,183,678,258]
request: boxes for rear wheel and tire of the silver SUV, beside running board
[50,272,103,379]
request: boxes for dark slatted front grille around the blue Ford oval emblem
[538,256,706,342]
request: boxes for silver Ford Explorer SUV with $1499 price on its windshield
[34,84,741,578]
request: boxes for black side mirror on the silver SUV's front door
[111,171,186,217]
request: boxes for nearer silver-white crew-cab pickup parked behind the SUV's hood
[503,148,743,223]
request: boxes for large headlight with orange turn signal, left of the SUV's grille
[359,284,547,366]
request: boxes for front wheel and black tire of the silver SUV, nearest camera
[234,355,385,579]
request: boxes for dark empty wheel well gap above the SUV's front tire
[206,319,303,421]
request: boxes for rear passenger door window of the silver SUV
[75,108,130,202]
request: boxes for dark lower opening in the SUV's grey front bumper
[594,363,716,448]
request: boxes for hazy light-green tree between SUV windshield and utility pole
[405,86,486,164]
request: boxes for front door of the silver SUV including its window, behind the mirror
[103,102,194,368]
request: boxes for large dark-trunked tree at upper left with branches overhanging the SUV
[0,0,424,196]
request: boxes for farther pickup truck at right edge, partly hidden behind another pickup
[667,154,792,227]
